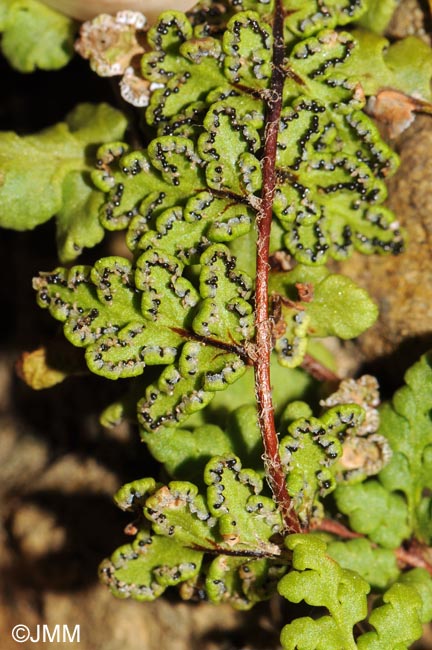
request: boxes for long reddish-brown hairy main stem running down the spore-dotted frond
[255,0,301,533]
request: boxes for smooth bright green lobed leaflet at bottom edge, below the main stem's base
[278,535,430,650]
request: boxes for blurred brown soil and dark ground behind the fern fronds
[0,0,432,650]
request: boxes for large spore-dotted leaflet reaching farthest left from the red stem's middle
[34,244,253,432]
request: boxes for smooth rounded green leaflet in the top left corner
[0,0,77,72]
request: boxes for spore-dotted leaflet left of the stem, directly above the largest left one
[92,137,252,264]
